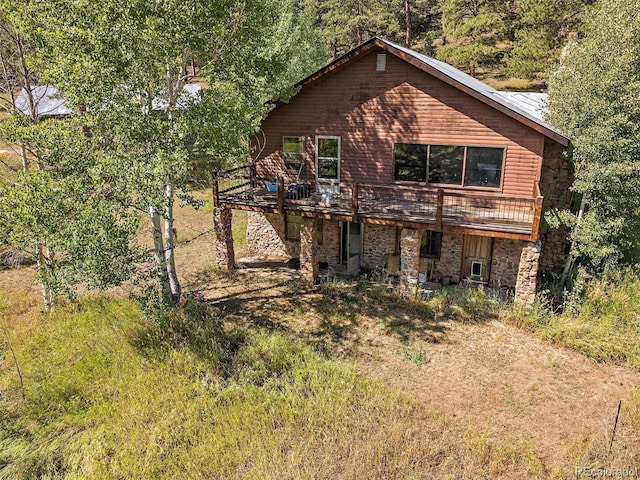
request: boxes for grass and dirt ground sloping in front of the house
[0,198,640,479]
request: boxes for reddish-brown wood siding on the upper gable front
[256,51,544,197]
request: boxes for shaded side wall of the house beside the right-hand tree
[540,143,574,273]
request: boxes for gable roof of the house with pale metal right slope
[298,37,569,147]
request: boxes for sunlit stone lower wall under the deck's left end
[247,212,300,258]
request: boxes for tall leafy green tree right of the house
[549,0,640,267]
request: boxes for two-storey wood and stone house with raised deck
[214,38,573,303]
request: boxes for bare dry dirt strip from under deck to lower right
[206,261,640,478]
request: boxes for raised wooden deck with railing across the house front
[214,167,542,241]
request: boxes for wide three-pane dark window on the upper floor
[393,143,505,188]
